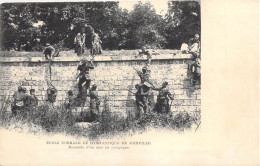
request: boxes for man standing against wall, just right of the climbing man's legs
[87,84,100,120]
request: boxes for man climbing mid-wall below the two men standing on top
[77,59,94,93]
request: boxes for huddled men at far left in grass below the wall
[11,86,38,115]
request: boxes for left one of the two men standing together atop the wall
[74,28,86,56]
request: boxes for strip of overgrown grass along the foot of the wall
[0,95,200,139]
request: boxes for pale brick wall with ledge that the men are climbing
[0,53,201,112]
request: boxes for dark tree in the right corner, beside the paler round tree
[165,1,201,49]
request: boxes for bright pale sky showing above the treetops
[119,0,168,16]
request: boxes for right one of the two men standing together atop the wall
[91,30,102,57]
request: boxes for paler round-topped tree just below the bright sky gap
[128,2,165,49]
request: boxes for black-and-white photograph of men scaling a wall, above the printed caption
[0,1,201,139]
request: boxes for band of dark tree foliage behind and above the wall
[0,1,200,51]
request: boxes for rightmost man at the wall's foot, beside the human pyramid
[154,81,174,114]
